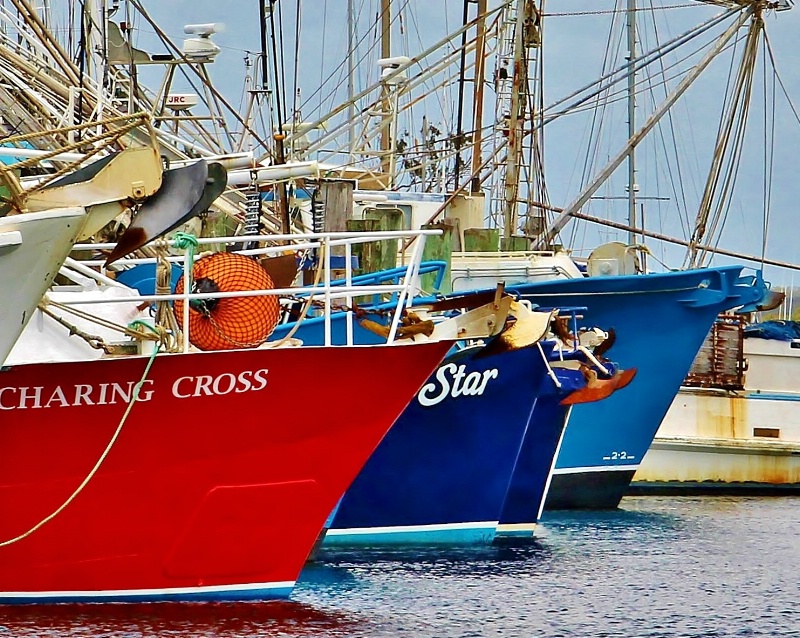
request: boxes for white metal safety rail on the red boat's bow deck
[67,230,442,352]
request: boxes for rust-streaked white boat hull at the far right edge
[633,338,800,493]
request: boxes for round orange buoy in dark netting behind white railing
[173,253,280,350]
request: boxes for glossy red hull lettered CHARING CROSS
[0,342,449,602]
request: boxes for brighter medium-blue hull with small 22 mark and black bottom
[509,266,763,509]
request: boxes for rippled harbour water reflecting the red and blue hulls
[0,497,800,638]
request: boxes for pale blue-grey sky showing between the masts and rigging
[131,0,800,285]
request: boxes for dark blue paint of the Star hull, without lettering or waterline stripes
[331,346,561,540]
